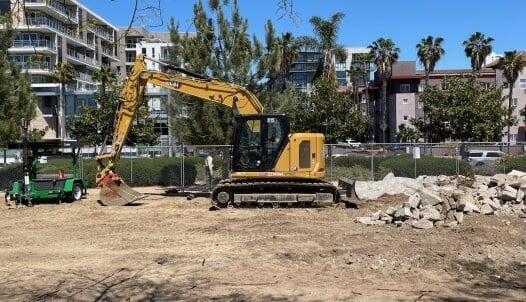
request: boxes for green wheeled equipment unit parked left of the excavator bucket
[5,139,89,206]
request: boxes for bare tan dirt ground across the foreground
[0,187,526,301]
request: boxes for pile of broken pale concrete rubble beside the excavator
[354,170,526,229]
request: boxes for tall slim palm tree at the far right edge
[498,50,526,151]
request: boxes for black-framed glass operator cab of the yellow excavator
[232,114,289,172]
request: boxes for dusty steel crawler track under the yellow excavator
[212,179,340,208]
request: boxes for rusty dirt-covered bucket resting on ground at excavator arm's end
[99,179,146,206]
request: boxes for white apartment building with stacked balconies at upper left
[0,0,119,139]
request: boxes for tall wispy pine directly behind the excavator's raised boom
[167,0,302,144]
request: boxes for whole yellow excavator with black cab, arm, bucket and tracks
[96,55,340,208]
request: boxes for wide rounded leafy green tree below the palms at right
[418,75,507,142]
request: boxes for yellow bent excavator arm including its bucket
[96,55,263,205]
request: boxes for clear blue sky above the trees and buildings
[80,0,526,69]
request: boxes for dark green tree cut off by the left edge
[0,14,39,147]
